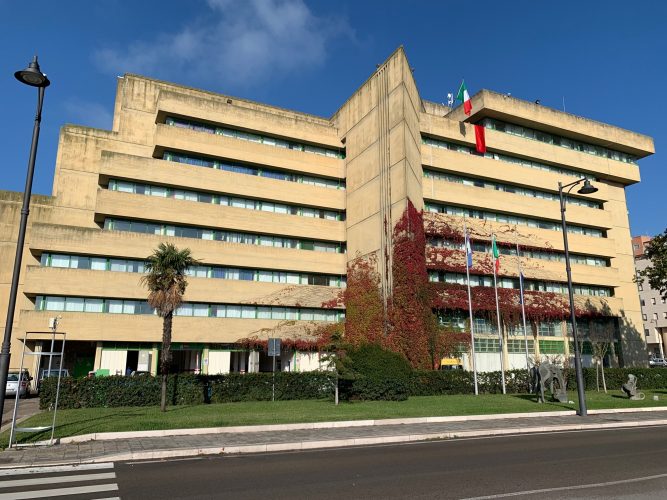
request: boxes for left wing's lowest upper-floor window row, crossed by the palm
[35,295,345,322]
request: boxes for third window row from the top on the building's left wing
[109,179,345,220]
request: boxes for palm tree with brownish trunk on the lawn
[141,243,197,411]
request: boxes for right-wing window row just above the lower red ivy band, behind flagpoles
[428,269,613,297]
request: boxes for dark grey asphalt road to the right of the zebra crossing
[115,427,667,500]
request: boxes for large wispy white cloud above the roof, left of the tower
[95,0,353,85]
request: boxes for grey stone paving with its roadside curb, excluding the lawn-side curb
[0,411,667,468]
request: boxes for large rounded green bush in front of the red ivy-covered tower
[339,344,412,401]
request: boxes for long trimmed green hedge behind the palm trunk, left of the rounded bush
[39,372,333,409]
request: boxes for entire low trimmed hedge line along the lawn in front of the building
[39,363,667,409]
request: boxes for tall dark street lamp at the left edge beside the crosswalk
[0,56,51,415]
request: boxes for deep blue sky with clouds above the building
[0,0,667,234]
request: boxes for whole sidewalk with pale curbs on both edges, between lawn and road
[0,407,667,468]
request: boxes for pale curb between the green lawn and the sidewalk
[54,406,667,446]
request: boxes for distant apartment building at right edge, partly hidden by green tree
[632,236,667,358]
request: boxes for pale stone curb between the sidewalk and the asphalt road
[5,419,667,469]
